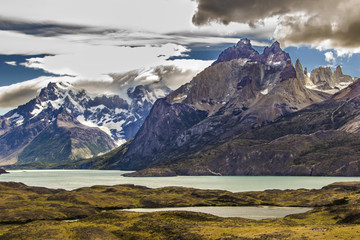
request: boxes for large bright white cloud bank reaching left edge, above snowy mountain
[0,31,205,79]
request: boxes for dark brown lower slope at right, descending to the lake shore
[119,81,360,176]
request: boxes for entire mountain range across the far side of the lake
[0,39,360,176]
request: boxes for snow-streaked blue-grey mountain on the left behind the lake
[0,83,170,167]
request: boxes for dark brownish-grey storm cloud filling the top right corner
[192,0,360,48]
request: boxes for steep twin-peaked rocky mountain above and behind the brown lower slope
[114,40,338,171]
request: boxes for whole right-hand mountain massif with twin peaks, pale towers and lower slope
[86,39,360,176]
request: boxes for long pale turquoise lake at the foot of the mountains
[0,170,360,192]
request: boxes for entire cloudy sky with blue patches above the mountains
[0,0,360,114]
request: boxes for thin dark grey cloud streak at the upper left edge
[0,17,113,37]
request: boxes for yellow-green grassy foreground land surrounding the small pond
[0,182,360,239]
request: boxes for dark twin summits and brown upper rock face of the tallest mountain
[167,39,296,114]
